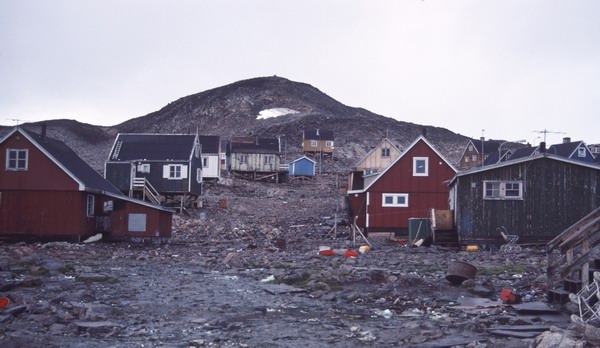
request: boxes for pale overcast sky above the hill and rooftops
[0,0,600,144]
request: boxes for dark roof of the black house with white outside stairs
[108,133,197,161]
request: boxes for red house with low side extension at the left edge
[0,127,172,241]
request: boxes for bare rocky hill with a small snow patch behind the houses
[0,76,467,172]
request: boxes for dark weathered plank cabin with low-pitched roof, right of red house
[450,151,600,244]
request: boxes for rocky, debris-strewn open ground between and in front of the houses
[0,174,600,347]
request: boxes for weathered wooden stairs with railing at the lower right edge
[546,208,600,312]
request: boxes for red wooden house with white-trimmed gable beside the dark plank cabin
[348,136,456,235]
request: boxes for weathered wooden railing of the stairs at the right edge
[546,208,600,289]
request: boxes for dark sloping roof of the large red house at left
[18,128,123,196]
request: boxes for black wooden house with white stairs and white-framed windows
[104,133,203,203]
